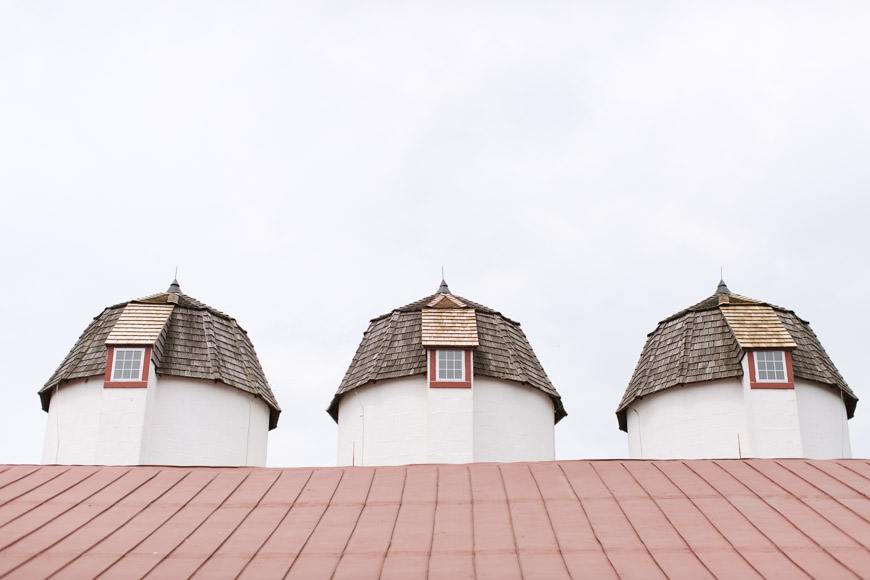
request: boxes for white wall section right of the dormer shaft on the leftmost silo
[142,376,269,466]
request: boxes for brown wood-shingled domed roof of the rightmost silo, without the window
[616,282,858,431]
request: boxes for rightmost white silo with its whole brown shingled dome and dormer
[616,281,858,459]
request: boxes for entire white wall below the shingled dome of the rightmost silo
[626,357,851,459]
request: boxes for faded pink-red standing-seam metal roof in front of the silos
[0,460,870,580]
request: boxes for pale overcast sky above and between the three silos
[0,0,870,466]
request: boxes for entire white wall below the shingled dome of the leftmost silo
[42,372,269,466]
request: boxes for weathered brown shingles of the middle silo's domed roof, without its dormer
[327,281,567,423]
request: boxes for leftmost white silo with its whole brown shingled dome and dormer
[39,280,281,465]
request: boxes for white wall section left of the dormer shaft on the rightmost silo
[626,379,747,459]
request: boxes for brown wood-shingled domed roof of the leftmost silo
[39,281,281,429]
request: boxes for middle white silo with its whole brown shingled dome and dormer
[327,280,566,465]
